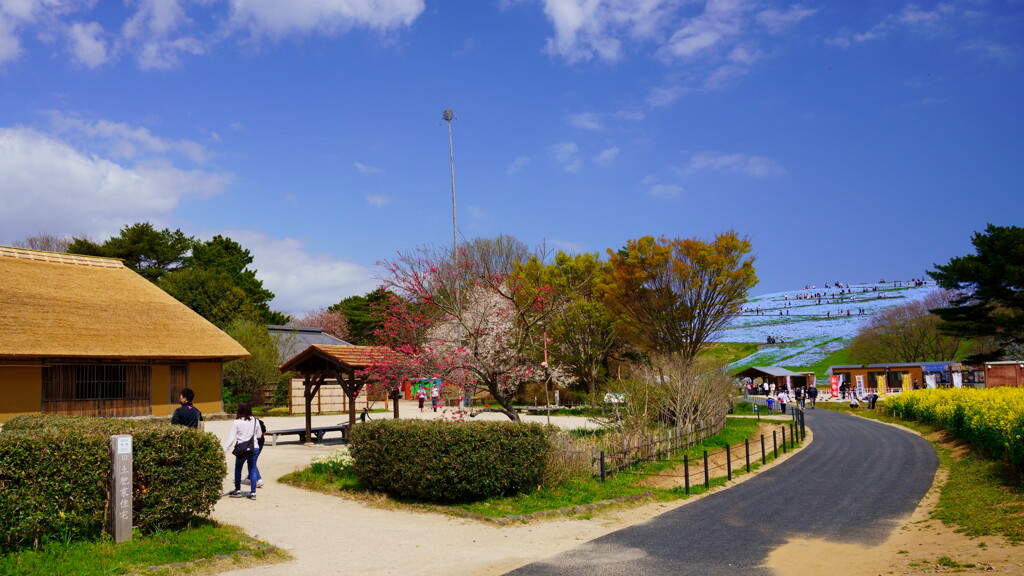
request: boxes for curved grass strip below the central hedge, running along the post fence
[282,418,798,518]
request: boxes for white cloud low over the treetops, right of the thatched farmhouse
[227,231,376,315]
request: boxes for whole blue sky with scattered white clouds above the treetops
[0,0,1024,313]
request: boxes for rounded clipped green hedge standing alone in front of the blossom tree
[350,420,551,502]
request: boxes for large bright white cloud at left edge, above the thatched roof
[0,128,232,242]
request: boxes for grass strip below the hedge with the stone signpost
[0,521,289,576]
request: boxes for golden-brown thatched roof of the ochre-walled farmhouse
[0,246,249,360]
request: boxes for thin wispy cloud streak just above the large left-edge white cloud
[48,111,211,163]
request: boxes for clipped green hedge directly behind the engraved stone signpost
[0,415,227,549]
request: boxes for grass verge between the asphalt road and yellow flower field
[818,403,1024,542]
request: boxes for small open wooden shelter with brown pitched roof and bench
[279,344,398,443]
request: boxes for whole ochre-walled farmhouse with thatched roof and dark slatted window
[0,246,249,421]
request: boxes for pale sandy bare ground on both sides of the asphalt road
[208,413,1024,576]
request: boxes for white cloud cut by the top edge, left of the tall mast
[230,0,424,38]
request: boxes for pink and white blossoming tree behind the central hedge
[370,239,573,421]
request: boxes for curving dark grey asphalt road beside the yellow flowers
[509,410,938,576]
